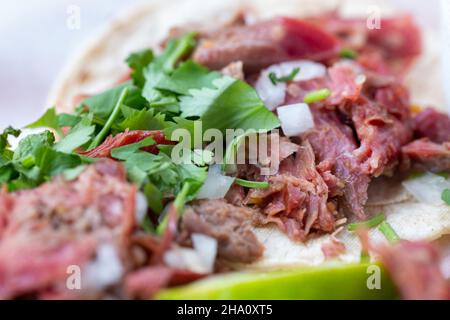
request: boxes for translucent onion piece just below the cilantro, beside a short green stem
[197,165,234,199]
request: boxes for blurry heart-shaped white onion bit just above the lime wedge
[164,234,217,273]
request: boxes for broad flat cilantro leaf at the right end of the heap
[180,76,280,131]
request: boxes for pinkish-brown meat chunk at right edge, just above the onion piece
[402,138,450,172]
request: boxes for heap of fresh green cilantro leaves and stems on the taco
[0,33,282,235]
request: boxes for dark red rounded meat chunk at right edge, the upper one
[414,108,450,143]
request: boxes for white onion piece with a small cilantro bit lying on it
[255,60,327,110]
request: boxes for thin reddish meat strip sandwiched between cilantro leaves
[81,130,174,158]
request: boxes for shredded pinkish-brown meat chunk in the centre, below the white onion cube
[246,141,335,241]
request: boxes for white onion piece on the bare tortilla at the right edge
[403,173,450,205]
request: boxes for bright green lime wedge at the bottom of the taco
[156,264,399,300]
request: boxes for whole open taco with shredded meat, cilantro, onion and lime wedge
[0,0,450,299]
